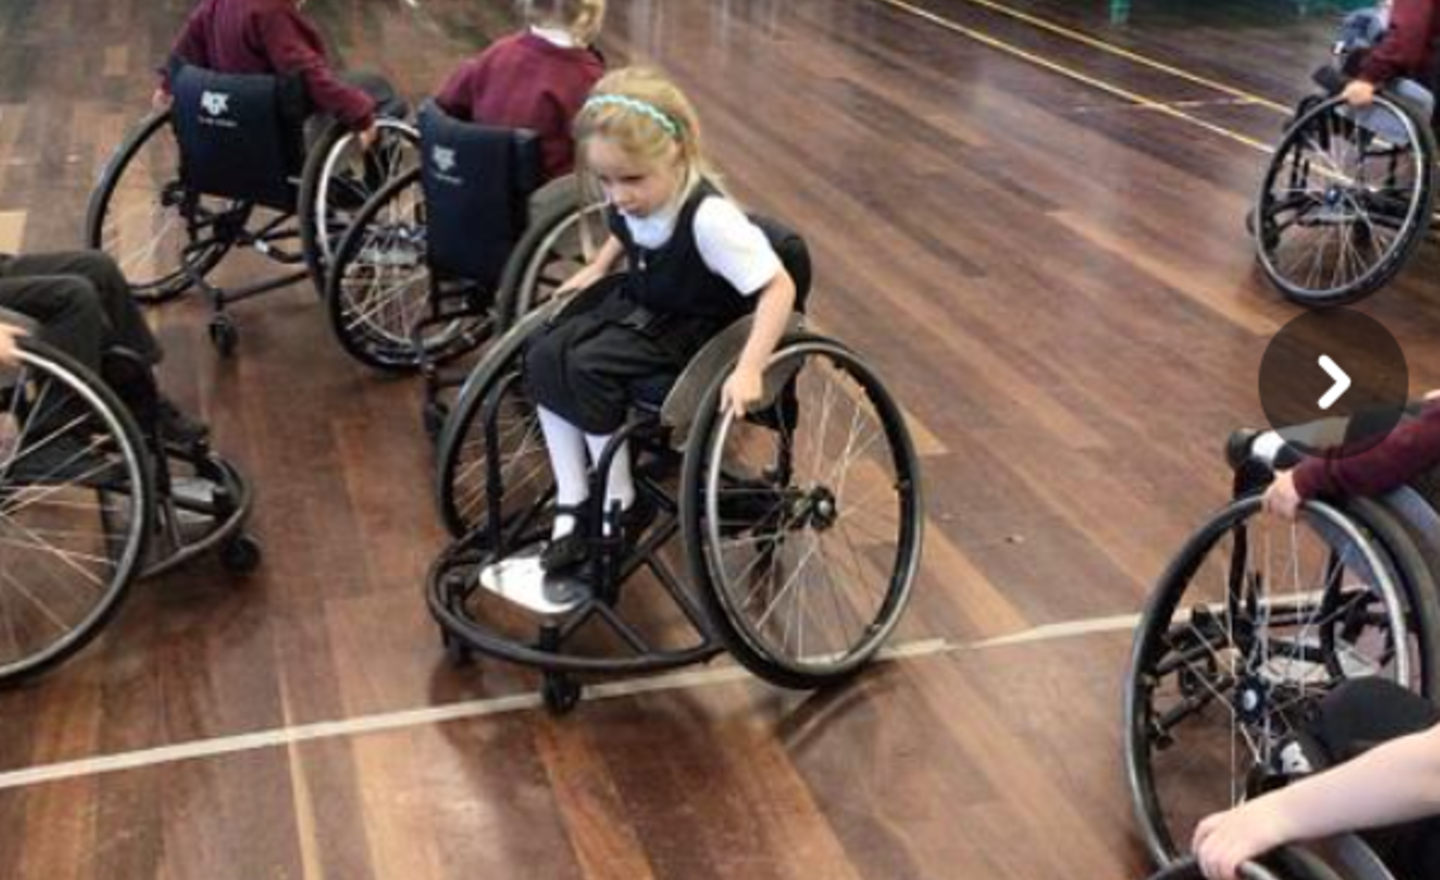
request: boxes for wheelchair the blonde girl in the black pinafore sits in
[426,225,923,713]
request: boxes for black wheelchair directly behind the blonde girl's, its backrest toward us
[325,102,605,434]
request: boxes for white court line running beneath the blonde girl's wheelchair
[0,615,1136,791]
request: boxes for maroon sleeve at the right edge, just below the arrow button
[1295,400,1440,498]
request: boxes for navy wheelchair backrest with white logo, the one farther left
[170,63,305,212]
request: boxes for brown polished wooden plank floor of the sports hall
[0,0,1440,880]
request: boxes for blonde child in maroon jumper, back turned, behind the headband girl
[435,0,605,180]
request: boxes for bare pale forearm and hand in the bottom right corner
[1194,727,1440,880]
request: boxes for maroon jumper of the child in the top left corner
[166,0,374,131]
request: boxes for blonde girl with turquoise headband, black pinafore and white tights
[524,69,795,573]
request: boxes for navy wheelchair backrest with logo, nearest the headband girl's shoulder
[419,101,541,288]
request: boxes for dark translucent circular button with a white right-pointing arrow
[1260,308,1410,455]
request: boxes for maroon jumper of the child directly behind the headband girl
[435,33,605,180]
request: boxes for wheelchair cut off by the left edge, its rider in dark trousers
[0,310,261,684]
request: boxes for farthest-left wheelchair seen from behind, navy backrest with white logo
[85,65,418,354]
